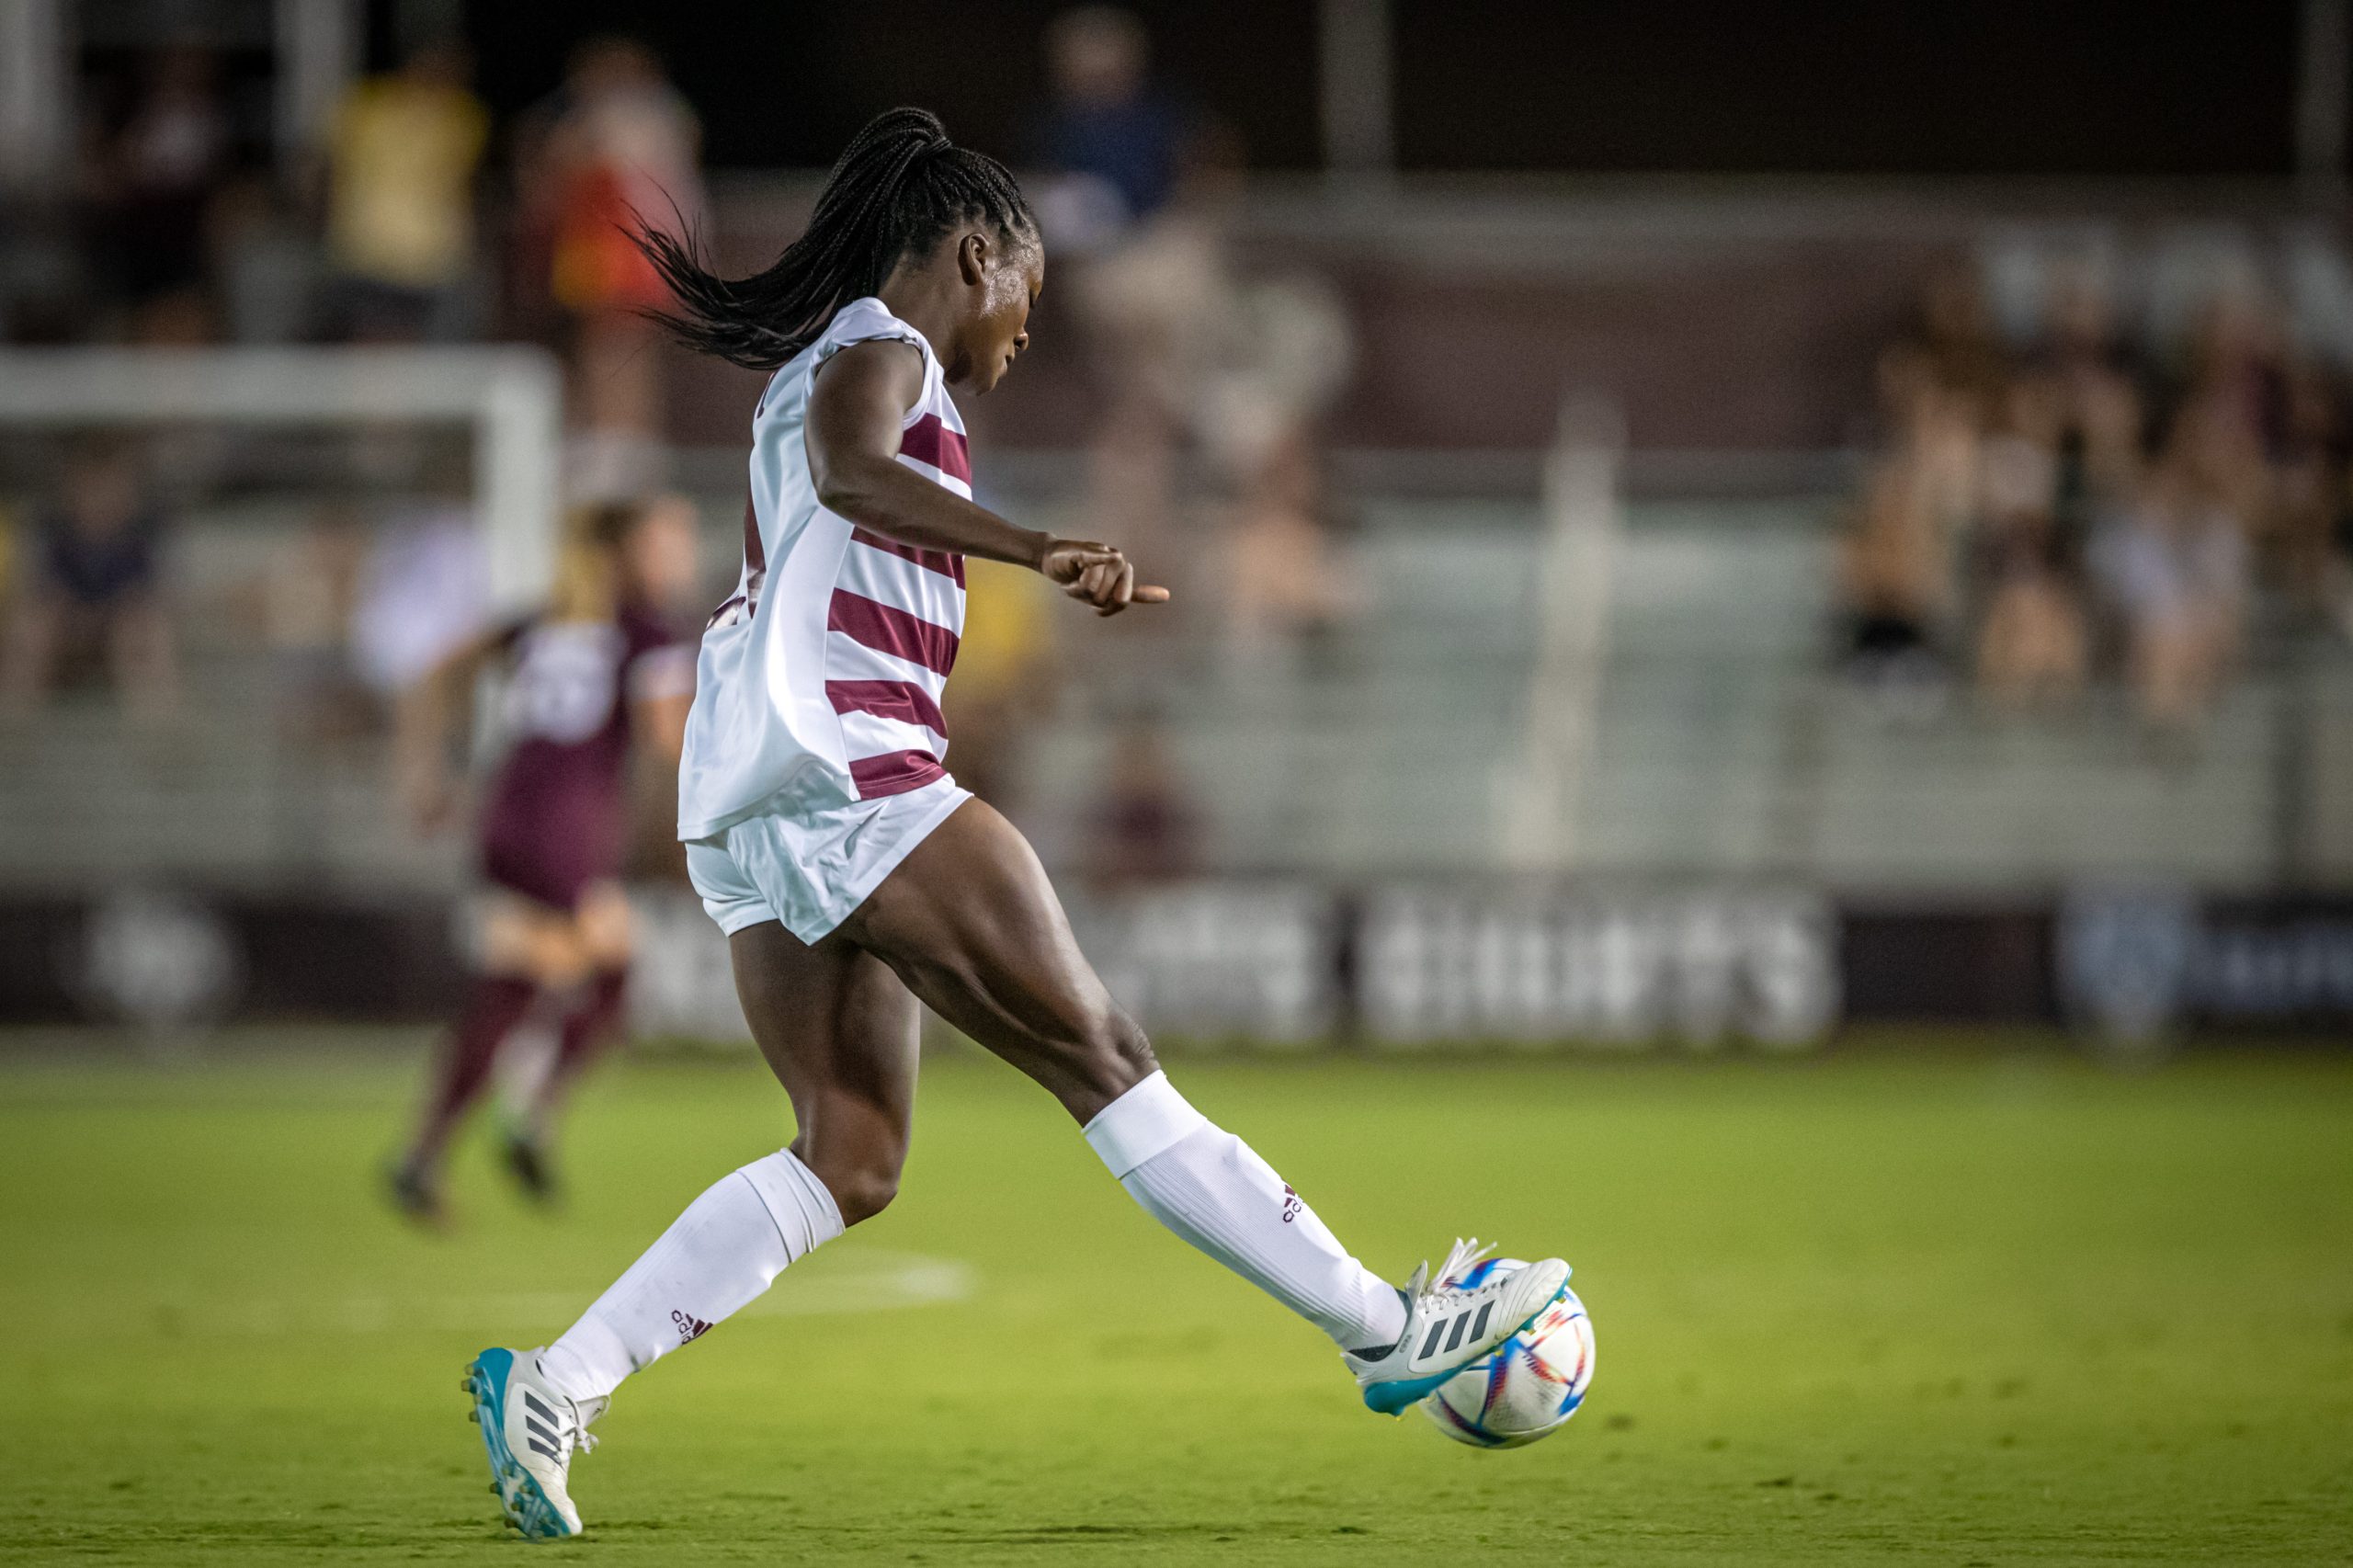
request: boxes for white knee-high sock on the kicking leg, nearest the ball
[1087,1074,1404,1349]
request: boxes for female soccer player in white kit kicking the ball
[466,108,1570,1538]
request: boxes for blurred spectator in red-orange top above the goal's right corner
[539,38,701,496]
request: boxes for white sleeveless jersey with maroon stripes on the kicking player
[677,299,972,840]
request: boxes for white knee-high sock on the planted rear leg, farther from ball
[539,1149,842,1399]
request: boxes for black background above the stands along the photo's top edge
[459,0,2297,176]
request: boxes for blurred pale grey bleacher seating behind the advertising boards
[0,502,2315,892]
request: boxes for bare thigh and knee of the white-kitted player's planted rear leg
[727,921,920,1220]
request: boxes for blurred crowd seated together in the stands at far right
[1840,264,2353,742]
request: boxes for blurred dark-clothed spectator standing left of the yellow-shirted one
[89,47,231,341]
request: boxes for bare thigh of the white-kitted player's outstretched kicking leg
[835,801,1153,1120]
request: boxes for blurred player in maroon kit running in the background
[391,496,694,1221]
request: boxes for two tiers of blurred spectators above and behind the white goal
[0,26,701,739]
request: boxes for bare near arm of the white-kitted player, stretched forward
[805,339,1169,615]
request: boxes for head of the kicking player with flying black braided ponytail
[638,108,1045,391]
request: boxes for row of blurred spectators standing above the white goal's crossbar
[0,38,701,494]
